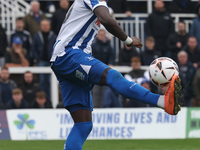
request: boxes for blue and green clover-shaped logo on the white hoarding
[14,114,35,130]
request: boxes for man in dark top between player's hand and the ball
[141,36,160,66]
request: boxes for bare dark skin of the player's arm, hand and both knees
[71,6,143,123]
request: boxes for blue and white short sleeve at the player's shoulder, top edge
[83,0,108,11]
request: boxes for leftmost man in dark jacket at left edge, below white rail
[0,67,17,106]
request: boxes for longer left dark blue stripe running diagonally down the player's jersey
[66,15,96,47]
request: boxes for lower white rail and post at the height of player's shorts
[9,66,148,108]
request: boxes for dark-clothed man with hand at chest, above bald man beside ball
[167,22,189,61]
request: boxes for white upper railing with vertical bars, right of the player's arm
[112,13,196,62]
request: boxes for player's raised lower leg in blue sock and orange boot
[106,69,180,115]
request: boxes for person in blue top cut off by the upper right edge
[190,6,200,47]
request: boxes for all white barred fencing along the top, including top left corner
[0,0,196,62]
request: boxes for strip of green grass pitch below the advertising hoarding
[0,139,200,150]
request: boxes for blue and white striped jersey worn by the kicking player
[50,0,108,62]
